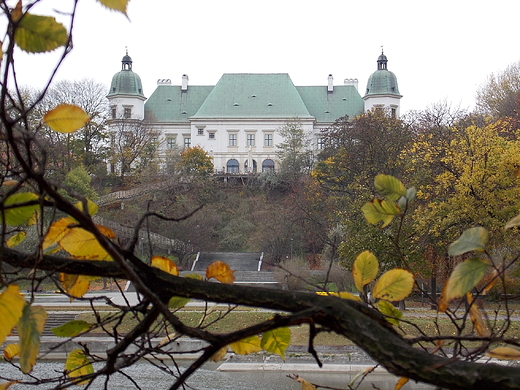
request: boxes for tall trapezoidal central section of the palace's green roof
[188,73,312,119]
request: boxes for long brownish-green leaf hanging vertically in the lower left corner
[18,304,47,374]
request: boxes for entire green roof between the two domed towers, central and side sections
[144,73,364,123]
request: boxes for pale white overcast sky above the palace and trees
[10,0,520,112]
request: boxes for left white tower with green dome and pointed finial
[107,50,146,120]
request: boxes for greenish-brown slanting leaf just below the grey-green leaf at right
[439,258,490,307]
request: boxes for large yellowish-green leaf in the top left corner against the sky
[14,14,68,53]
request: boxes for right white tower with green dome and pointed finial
[363,50,403,117]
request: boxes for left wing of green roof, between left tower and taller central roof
[144,84,213,123]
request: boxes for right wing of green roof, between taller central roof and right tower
[296,85,364,123]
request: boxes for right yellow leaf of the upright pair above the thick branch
[372,268,414,301]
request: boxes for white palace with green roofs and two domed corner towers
[107,53,402,173]
